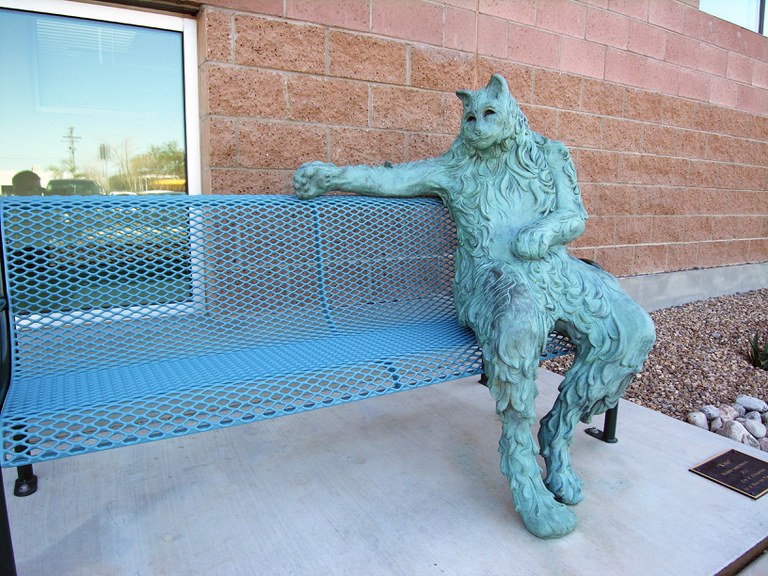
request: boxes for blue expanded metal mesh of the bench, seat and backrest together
[0,195,568,466]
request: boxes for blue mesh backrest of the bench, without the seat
[0,195,462,377]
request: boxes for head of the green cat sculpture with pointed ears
[456,74,527,151]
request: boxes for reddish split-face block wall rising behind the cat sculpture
[199,0,768,276]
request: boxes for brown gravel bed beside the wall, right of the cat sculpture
[543,289,768,420]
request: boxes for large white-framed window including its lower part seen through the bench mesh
[0,0,201,318]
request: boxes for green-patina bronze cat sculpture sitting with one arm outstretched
[293,75,655,538]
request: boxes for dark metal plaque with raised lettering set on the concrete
[691,449,768,500]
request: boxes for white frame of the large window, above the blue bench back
[0,0,202,196]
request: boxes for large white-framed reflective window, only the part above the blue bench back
[0,0,200,196]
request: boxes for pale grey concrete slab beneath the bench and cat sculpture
[5,372,768,576]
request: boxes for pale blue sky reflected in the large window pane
[0,9,184,185]
